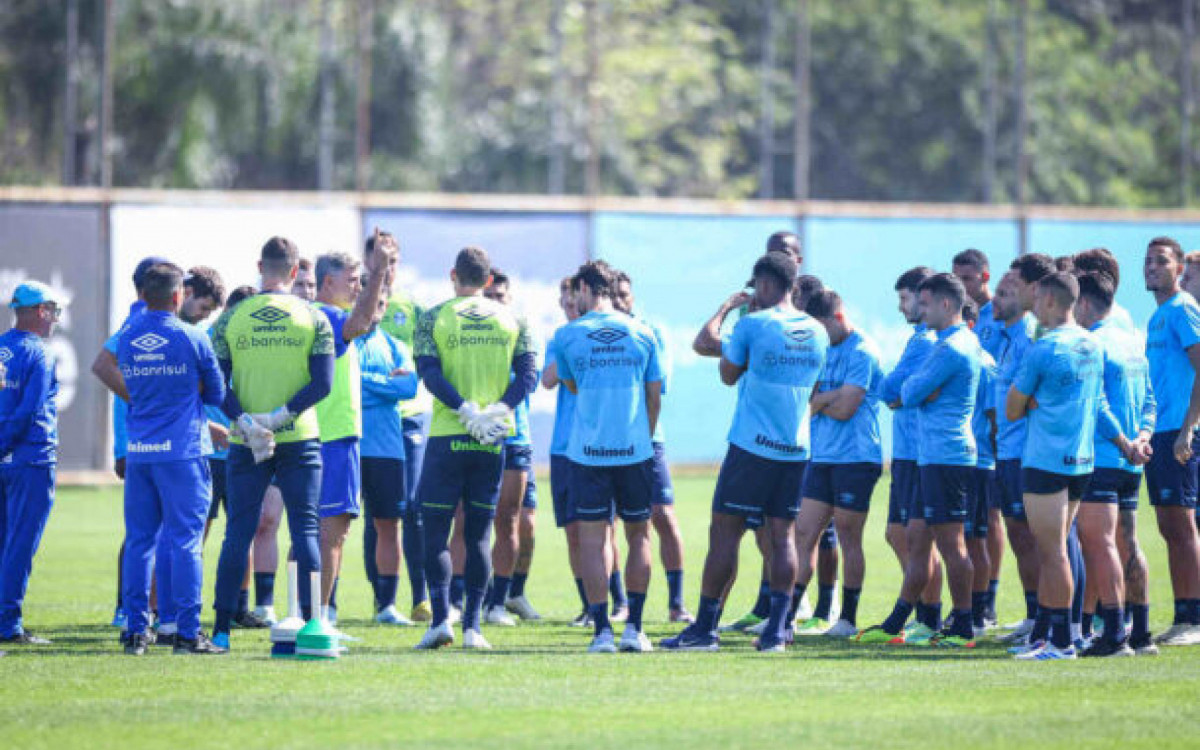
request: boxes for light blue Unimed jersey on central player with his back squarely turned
[554,312,662,466]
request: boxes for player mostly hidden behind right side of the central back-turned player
[613,271,695,623]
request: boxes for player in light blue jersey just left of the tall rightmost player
[1075,272,1158,656]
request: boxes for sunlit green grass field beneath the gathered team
[7,474,1200,750]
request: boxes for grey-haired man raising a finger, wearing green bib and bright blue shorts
[316,244,395,624]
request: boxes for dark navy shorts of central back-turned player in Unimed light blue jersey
[571,458,654,523]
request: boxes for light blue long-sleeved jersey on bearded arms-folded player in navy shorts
[900,323,983,466]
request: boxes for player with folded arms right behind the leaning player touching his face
[785,290,883,637]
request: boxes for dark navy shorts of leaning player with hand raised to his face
[713,444,809,528]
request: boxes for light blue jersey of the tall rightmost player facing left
[1146,292,1200,432]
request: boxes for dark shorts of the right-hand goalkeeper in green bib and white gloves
[416,436,504,518]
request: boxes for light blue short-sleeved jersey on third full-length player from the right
[1013,323,1111,476]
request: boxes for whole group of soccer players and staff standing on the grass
[0,230,1200,660]
